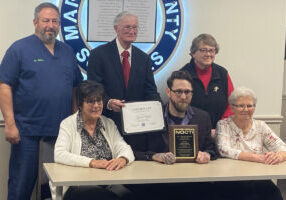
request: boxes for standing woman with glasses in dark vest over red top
[181,34,233,134]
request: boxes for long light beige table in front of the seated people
[44,159,286,199]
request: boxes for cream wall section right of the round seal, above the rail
[156,0,286,116]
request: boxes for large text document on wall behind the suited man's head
[87,0,157,43]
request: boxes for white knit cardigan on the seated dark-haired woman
[49,112,134,199]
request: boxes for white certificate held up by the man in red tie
[122,101,165,135]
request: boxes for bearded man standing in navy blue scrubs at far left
[0,3,82,200]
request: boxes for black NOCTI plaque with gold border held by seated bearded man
[169,125,198,162]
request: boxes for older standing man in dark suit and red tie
[87,12,160,142]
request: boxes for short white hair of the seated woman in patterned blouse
[228,87,257,105]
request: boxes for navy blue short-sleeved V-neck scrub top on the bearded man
[0,35,82,136]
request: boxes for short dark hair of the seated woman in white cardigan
[77,80,104,107]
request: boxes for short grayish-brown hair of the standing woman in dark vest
[190,33,219,54]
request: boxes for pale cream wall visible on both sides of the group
[0,0,286,199]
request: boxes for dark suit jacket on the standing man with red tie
[87,40,160,138]
